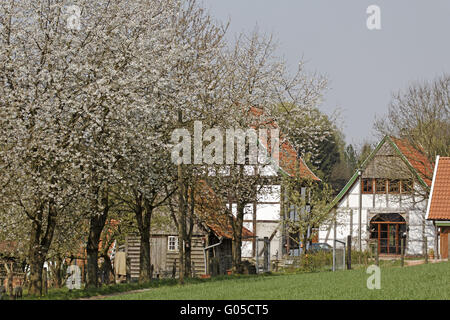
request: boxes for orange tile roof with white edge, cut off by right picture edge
[427,157,450,220]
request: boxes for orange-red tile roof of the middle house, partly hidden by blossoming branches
[250,107,320,181]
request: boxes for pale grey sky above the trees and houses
[204,0,450,144]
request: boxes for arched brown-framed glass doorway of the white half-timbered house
[370,213,406,254]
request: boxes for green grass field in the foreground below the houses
[107,262,450,300]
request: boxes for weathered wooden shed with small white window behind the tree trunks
[126,181,254,280]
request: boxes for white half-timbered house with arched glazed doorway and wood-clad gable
[319,136,435,255]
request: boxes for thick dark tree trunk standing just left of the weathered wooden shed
[86,214,108,288]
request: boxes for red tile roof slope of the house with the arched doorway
[390,137,433,187]
